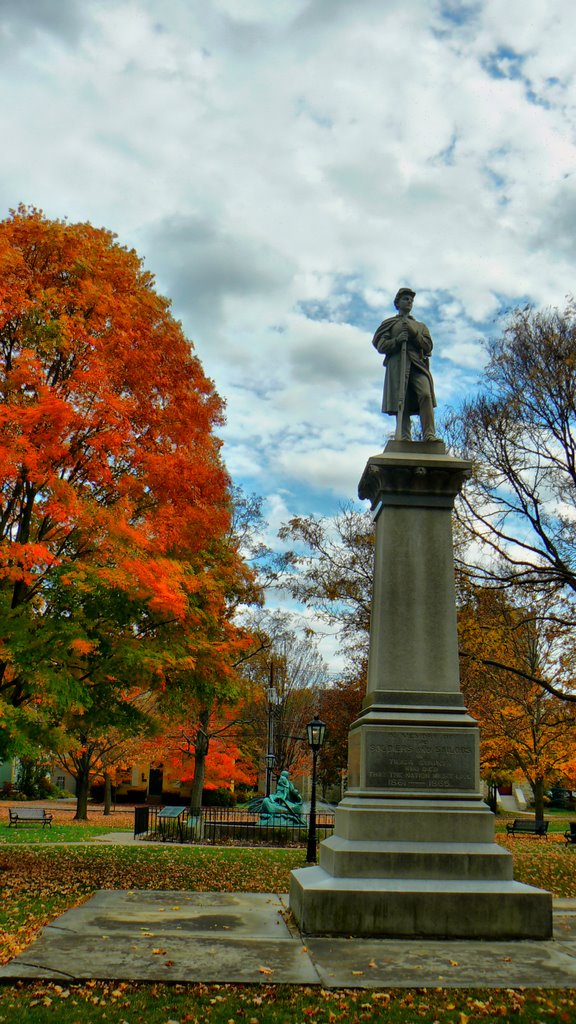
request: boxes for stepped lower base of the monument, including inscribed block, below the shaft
[290,694,552,940]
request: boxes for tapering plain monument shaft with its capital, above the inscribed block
[359,441,469,703]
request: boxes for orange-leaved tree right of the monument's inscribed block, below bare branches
[458,585,576,819]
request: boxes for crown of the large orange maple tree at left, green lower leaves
[0,201,251,782]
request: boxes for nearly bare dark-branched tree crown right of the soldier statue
[447,302,576,700]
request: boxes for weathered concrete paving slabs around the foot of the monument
[0,890,576,988]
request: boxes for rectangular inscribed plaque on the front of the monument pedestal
[366,729,477,791]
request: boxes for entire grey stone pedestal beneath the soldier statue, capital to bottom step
[290,441,552,939]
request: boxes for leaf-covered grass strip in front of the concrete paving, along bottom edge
[0,982,576,1024]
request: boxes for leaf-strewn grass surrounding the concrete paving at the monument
[0,822,576,1024]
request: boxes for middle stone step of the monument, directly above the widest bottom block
[320,836,513,881]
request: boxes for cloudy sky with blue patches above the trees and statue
[0,0,576,663]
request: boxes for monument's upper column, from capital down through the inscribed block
[348,441,481,802]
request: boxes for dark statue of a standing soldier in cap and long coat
[372,288,437,441]
